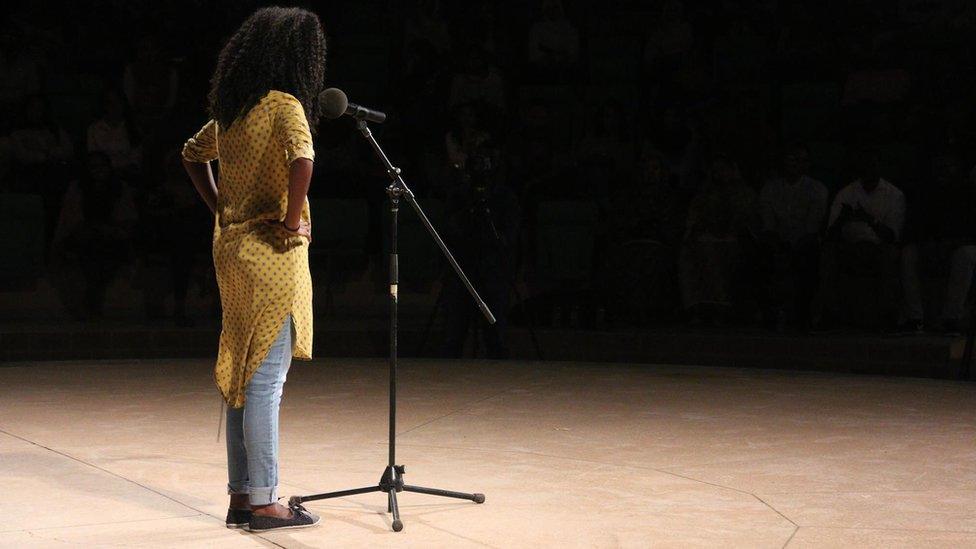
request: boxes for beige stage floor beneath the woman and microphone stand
[0,359,976,548]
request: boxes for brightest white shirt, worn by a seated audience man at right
[828,178,905,243]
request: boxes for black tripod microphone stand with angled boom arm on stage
[288,118,495,532]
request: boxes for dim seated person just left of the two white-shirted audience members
[678,154,758,324]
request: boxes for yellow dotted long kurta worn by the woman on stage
[183,90,315,408]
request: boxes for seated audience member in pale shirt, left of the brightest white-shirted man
[759,144,828,329]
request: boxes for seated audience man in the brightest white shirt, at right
[821,150,905,324]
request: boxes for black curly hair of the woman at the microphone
[207,6,325,132]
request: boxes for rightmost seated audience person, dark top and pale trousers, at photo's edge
[901,151,976,333]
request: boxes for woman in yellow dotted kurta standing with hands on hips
[183,7,325,531]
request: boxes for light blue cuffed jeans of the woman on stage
[227,315,292,505]
